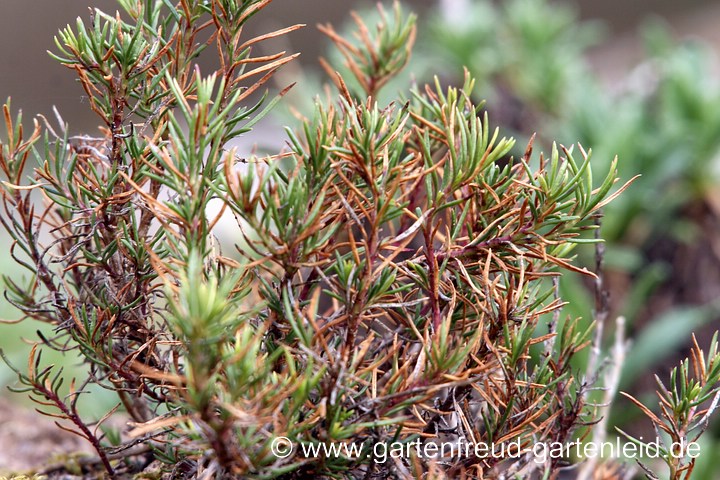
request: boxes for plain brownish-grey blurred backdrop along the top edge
[0,0,720,131]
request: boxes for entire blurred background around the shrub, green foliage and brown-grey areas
[0,0,720,480]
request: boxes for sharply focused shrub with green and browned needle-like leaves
[0,0,718,478]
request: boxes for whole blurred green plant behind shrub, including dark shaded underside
[423,0,720,334]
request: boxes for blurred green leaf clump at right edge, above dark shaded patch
[561,24,720,249]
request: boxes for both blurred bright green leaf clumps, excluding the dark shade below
[421,0,720,253]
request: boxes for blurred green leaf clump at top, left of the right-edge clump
[426,0,599,114]
